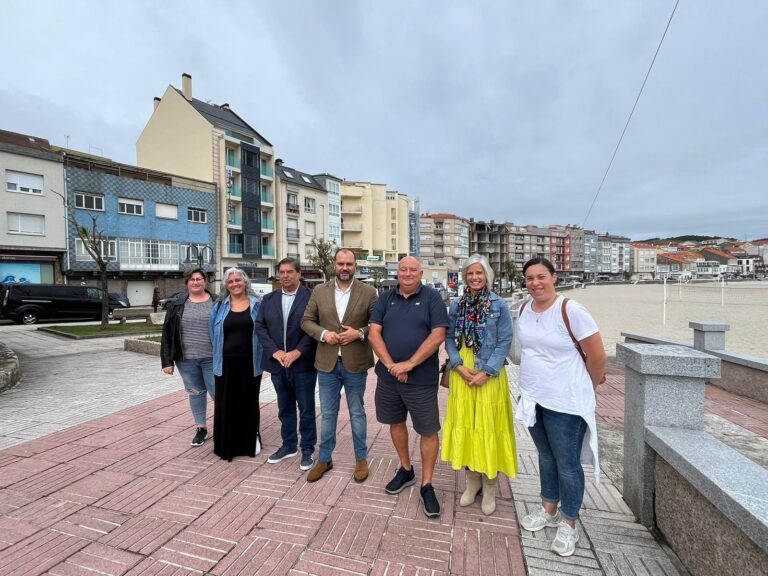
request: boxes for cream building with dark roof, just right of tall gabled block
[275,159,329,280]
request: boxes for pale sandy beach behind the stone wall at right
[564,282,768,358]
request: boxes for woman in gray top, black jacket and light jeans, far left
[160,268,216,446]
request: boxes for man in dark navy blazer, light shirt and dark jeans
[255,258,317,470]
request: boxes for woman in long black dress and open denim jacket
[210,268,262,462]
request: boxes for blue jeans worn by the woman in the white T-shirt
[528,405,587,520]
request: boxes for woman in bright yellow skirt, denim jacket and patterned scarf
[442,254,517,515]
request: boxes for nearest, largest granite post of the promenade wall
[616,344,720,526]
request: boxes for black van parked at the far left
[0,284,112,324]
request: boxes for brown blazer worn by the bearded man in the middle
[301,278,378,373]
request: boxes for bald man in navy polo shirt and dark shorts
[368,256,448,517]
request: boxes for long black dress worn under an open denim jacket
[213,308,261,462]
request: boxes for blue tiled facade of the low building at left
[65,166,219,275]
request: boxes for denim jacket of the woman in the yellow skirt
[445,293,512,376]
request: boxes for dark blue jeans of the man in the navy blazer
[272,368,317,454]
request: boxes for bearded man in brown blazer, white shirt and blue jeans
[301,248,377,482]
